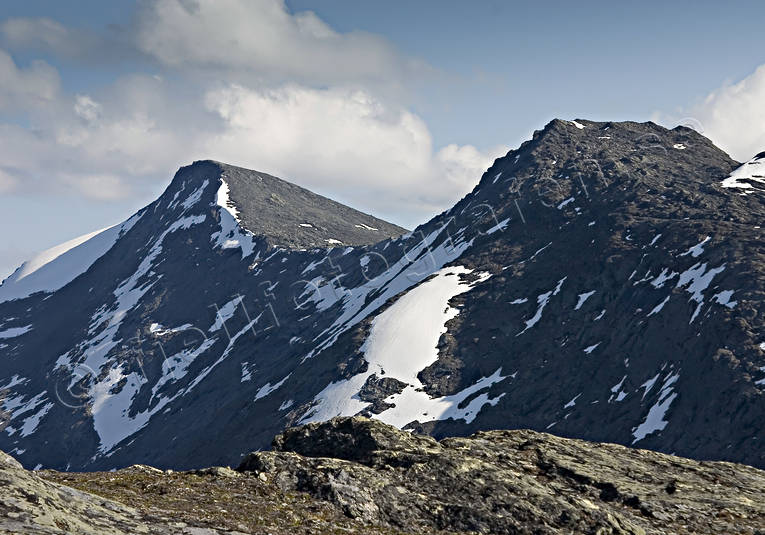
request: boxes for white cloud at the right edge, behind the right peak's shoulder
[656,65,765,161]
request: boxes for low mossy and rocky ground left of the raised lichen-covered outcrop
[5,452,418,535]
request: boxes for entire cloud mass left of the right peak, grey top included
[0,0,506,226]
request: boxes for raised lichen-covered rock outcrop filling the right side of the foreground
[239,417,765,535]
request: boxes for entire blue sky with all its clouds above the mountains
[0,0,765,279]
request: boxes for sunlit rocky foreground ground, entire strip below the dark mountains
[0,418,765,535]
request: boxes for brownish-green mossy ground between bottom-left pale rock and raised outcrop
[38,467,448,535]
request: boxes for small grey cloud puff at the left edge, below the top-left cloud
[0,50,59,111]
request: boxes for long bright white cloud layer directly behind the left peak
[0,64,503,225]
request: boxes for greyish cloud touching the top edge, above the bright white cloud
[135,0,415,84]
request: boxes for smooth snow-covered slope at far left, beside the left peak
[0,212,141,303]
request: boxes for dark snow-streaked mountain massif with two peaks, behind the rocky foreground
[0,120,765,470]
